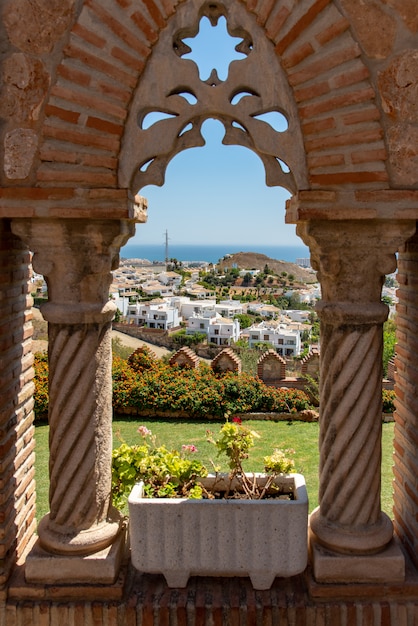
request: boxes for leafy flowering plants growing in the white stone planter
[112,418,294,507]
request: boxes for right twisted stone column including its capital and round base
[298,221,416,555]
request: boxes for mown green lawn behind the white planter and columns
[35,419,393,520]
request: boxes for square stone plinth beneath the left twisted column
[25,528,126,586]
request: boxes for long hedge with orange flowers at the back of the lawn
[35,348,310,418]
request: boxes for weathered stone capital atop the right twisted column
[297,219,415,304]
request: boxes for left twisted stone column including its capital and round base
[13,220,134,555]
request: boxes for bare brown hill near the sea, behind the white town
[218,252,317,283]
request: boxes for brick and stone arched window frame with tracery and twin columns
[0,0,418,608]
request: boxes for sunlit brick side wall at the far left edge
[0,223,35,597]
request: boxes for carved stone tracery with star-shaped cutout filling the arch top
[119,2,307,193]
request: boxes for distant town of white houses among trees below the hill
[32,247,396,359]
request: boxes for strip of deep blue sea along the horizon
[120,244,309,263]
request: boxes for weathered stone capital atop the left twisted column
[12,219,135,324]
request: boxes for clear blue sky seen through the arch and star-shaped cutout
[128,18,303,247]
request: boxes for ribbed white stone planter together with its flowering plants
[113,420,308,589]
